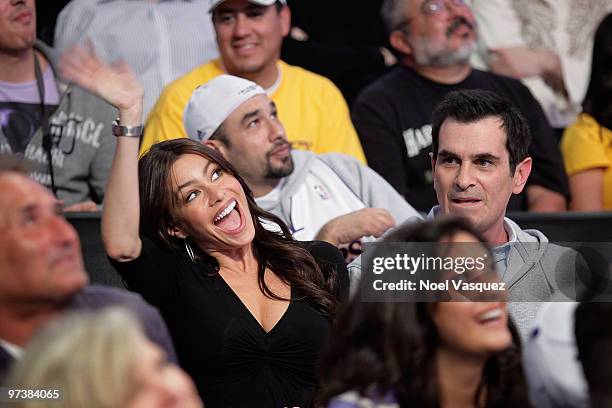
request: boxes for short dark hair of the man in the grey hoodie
[431,89,531,174]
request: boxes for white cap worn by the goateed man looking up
[183,75,266,142]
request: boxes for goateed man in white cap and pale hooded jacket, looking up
[185,75,419,260]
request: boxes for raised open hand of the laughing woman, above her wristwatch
[60,47,144,121]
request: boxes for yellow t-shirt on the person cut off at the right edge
[561,113,612,210]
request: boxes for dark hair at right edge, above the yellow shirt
[582,14,612,129]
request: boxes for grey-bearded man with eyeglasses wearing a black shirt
[352,0,569,215]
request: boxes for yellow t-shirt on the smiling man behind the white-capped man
[140,59,365,163]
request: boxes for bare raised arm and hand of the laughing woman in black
[61,48,144,261]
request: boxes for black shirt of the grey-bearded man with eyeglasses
[352,66,569,212]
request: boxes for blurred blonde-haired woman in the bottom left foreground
[6,307,202,408]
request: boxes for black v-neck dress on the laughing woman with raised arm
[112,238,348,408]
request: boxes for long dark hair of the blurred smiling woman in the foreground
[318,218,531,408]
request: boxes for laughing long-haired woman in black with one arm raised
[63,50,348,408]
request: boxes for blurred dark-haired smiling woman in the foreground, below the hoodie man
[320,217,530,408]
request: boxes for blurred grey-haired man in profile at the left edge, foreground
[0,156,176,383]
